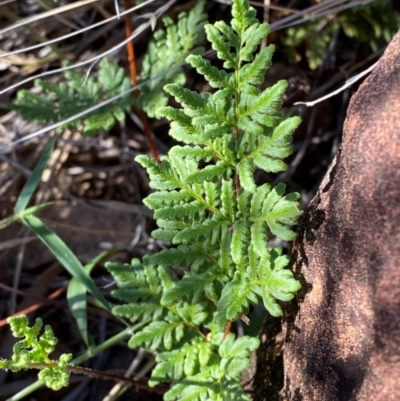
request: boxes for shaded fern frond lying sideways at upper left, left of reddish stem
[8,58,132,135]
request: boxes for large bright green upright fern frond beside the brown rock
[107,0,300,401]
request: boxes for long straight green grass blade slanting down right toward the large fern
[22,215,111,312]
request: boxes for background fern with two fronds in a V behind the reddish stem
[7,1,207,135]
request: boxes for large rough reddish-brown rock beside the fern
[283,32,400,401]
